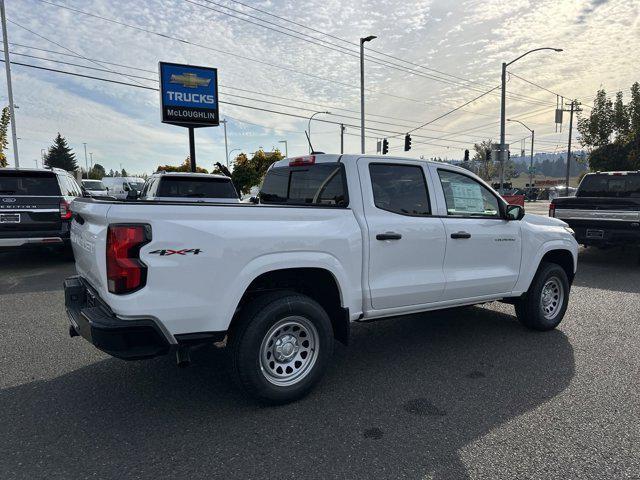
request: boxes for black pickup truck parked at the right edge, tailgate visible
[549,171,640,247]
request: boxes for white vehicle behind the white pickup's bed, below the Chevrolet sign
[140,172,240,203]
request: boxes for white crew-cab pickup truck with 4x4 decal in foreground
[65,154,578,403]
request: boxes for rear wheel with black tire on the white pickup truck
[229,291,334,404]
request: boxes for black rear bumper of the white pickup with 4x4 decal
[64,276,172,360]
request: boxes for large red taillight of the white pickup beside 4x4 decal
[107,225,151,294]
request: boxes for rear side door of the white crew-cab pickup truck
[358,158,446,310]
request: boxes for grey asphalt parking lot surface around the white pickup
[0,238,640,479]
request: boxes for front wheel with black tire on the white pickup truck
[514,262,571,331]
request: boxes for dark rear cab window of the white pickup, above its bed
[260,163,349,207]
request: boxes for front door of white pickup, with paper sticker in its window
[431,166,522,300]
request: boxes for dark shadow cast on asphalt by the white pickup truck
[0,307,575,479]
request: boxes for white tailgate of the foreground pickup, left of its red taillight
[71,199,111,295]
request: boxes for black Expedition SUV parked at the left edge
[0,168,82,247]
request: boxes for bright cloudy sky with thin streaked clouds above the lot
[0,0,640,173]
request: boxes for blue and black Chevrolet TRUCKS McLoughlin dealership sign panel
[160,62,219,127]
